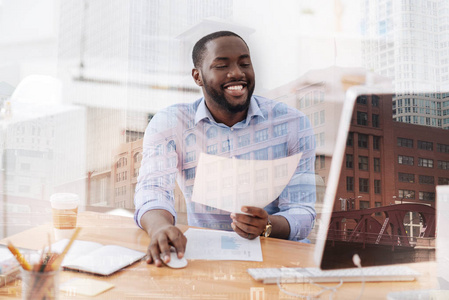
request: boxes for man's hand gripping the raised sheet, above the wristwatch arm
[231,206,268,240]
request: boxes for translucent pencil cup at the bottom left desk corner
[21,269,59,300]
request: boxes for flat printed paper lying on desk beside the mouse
[184,228,263,261]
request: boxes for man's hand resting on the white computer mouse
[147,225,187,267]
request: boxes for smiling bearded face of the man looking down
[194,36,255,113]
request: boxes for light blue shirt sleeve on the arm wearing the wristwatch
[274,113,316,241]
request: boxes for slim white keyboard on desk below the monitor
[248,266,420,284]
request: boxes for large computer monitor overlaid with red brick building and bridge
[312,86,438,269]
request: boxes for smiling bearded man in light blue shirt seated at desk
[134,31,315,267]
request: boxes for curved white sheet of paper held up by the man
[192,153,302,213]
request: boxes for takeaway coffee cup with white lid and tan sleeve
[50,193,80,240]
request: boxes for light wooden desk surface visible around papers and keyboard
[0,212,437,299]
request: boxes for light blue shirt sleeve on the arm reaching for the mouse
[134,110,178,228]
